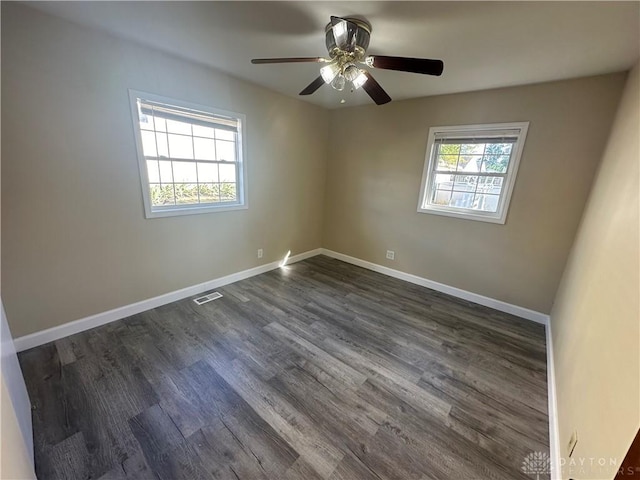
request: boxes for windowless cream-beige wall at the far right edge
[551,62,640,479]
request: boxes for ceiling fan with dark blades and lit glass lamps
[251,17,444,105]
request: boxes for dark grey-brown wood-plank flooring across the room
[20,256,549,480]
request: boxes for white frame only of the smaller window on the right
[418,122,529,224]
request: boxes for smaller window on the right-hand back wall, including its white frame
[418,122,529,223]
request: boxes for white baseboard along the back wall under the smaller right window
[320,248,549,325]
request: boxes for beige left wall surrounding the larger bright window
[2,2,328,336]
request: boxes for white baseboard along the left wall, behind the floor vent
[13,248,322,352]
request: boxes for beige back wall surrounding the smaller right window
[323,74,625,313]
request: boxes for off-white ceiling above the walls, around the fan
[29,1,640,108]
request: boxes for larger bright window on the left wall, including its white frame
[129,90,246,218]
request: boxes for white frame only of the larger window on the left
[129,89,248,218]
